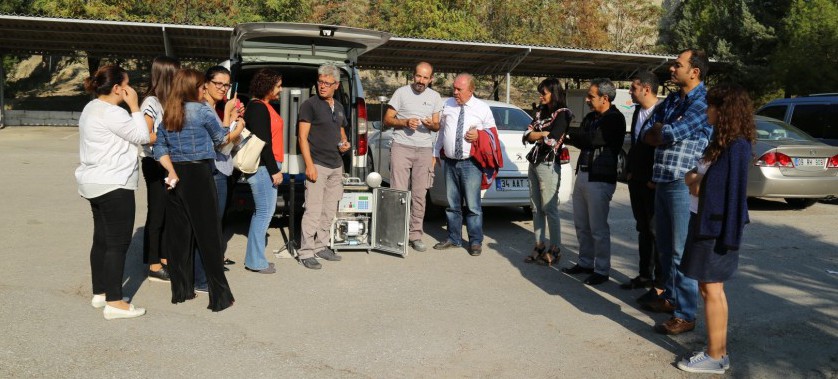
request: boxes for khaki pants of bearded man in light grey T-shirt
[390,143,434,241]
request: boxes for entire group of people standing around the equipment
[76,49,755,373]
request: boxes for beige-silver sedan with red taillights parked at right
[748,116,838,209]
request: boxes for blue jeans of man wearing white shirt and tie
[444,158,483,246]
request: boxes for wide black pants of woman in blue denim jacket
[163,160,234,312]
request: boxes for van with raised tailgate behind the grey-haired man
[223,22,390,215]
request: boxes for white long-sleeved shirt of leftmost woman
[76,99,150,198]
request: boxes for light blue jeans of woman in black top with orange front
[244,162,282,270]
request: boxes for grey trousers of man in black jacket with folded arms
[573,171,617,275]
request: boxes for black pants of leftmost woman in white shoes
[88,189,136,301]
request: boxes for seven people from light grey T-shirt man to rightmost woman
[384,49,756,373]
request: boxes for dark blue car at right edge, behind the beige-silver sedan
[757,93,838,146]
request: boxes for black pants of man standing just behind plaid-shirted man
[628,181,663,288]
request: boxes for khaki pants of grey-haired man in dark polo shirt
[297,164,343,259]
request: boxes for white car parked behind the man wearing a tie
[367,101,573,209]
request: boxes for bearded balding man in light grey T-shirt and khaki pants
[384,62,442,251]
